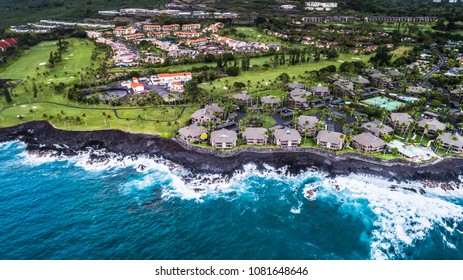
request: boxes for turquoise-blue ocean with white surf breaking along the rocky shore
[0,142,463,260]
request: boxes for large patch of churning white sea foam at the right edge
[326,175,463,259]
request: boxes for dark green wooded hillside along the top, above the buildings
[0,0,463,29]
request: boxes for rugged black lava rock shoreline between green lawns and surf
[0,121,463,182]
